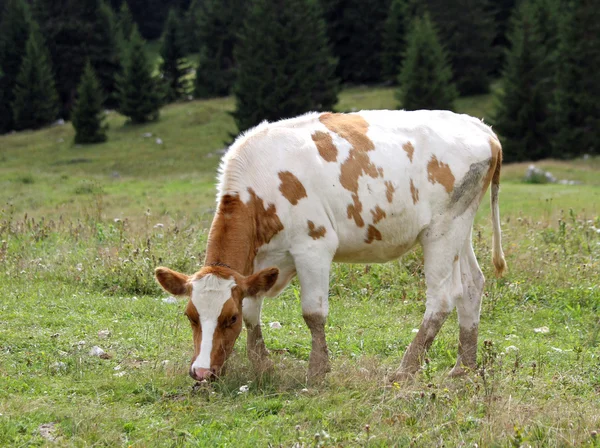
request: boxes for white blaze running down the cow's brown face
[192,274,235,369]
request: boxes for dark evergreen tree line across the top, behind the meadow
[0,0,600,161]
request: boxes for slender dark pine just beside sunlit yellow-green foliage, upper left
[160,9,188,102]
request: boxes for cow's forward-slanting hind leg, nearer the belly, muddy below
[394,219,472,380]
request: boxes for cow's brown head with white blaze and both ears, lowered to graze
[154,266,279,381]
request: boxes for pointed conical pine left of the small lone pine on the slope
[12,23,58,129]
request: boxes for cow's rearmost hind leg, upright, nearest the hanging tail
[450,233,485,376]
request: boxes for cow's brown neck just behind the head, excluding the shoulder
[205,195,256,275]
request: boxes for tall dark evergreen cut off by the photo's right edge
[552,0,600,158]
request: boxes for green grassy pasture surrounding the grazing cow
[0,88,600,447]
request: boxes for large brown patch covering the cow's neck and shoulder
[205,188,283,275]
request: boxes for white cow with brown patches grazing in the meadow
[155,110,506,383]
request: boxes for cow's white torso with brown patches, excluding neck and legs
[220,111,495,262]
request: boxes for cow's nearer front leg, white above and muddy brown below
[294,250,332,384]
